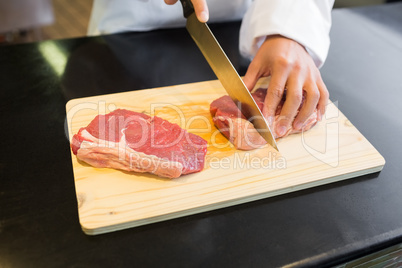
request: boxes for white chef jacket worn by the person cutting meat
[88,0,335,67]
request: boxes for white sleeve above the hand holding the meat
[239,0,335,67]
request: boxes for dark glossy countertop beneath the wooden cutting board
[0,4,402,268]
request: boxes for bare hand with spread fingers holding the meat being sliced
[244,35,329,136]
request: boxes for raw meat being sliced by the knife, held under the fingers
[210,88,318,150]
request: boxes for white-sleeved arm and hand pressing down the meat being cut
[240,0,334,136]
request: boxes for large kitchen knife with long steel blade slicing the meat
[180,0,279,151]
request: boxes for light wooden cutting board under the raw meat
[66,80,385,235]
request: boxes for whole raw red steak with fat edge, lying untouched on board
[71,109,207,178]
